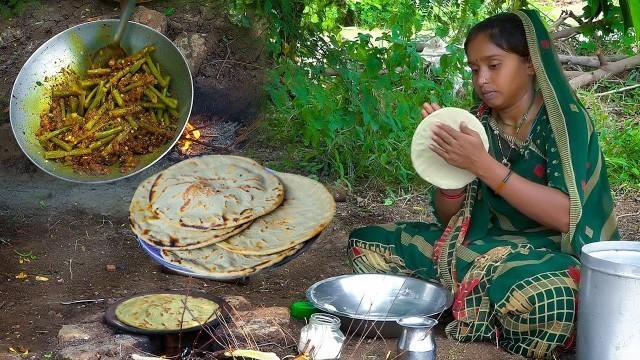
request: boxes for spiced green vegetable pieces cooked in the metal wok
[36,46,178,174]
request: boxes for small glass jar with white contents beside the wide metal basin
[298,313,345,360]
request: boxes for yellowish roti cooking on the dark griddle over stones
[115,294,220,330]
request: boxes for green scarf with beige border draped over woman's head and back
[516,10,619,256]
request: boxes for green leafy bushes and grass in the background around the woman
[229,0,640,187]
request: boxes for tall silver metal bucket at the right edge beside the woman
[577,241,640,360]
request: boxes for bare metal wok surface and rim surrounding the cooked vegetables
[9,20,193,183]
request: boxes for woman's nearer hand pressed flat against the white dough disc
[431,122,490,174]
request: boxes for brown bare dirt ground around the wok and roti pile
[0,0,640,360]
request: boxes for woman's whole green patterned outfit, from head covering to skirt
[348,10,618,359]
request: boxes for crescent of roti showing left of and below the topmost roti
[129,175,251,250]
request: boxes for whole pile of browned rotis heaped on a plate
[129,155,335,279]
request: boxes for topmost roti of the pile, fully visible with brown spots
[149,155,284,229]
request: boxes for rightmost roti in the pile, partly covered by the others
[216,172,336,255]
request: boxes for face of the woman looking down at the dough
[467,33,534,110]
